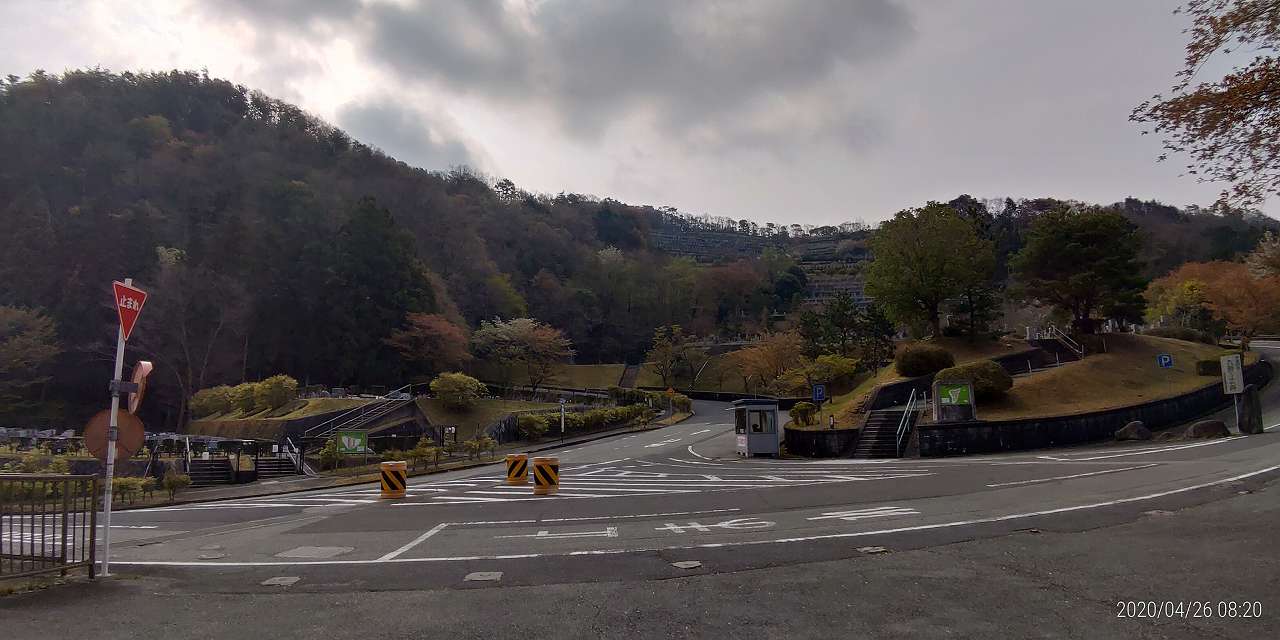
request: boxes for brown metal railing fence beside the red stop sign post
[0,474,100,580]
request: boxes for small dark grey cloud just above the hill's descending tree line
[338,99,481,169]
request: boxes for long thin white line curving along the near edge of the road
[114,465,1280,567]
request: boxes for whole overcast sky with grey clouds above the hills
[0,0,1259,224]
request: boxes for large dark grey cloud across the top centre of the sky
[212,0,914,148]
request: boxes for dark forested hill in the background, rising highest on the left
[0,70,1260,428]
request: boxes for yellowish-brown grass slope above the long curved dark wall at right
[978,334,1258,420]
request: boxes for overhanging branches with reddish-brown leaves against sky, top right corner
[1129,0,1280,205]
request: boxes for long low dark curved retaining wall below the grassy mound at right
[916,361,1272,457]
